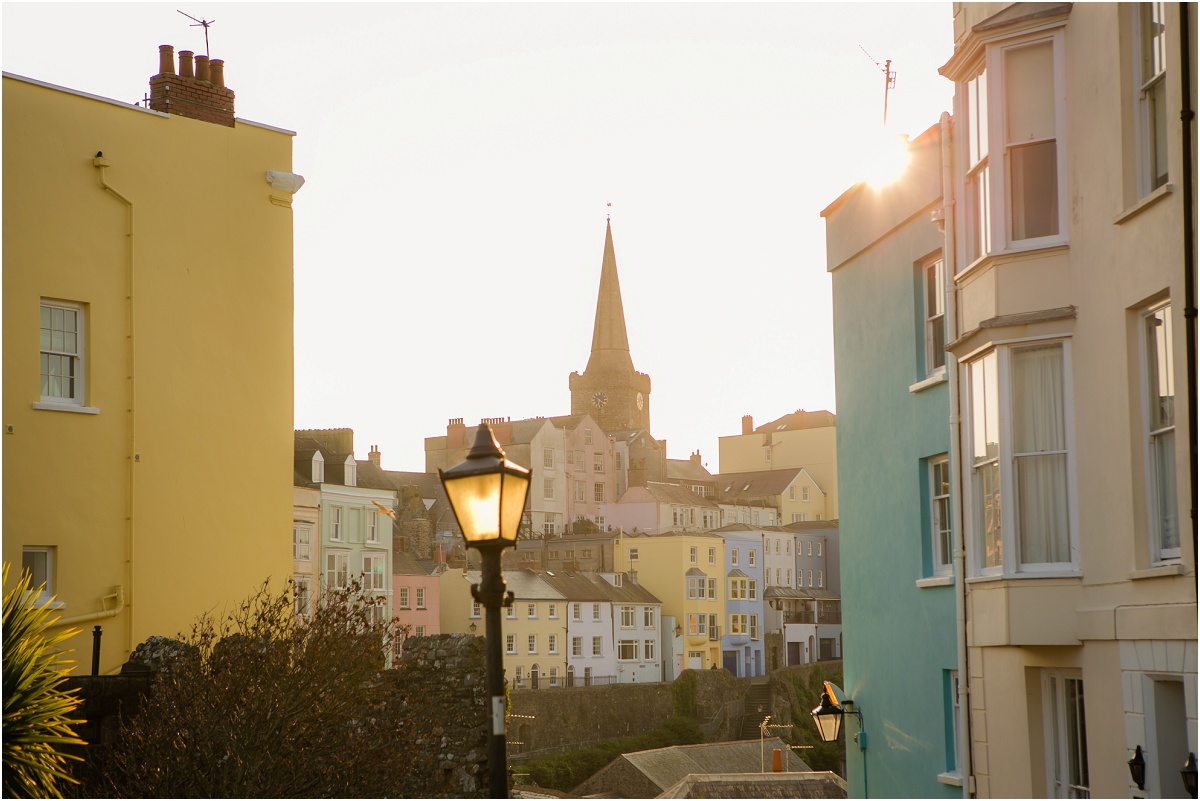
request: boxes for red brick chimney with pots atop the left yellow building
[150,44,234,128]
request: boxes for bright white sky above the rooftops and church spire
[0,0,953,472]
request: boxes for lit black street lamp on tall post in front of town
[438,423,530,799]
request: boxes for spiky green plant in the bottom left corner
[2,562,85,799]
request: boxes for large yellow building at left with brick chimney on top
[2,47,302,673]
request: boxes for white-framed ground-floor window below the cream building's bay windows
[1042,669,1091,799]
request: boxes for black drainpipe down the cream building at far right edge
[1180,2,1200,580]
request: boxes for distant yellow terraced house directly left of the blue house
[613,531,726,677]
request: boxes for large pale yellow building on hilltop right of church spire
[718,409,838,523]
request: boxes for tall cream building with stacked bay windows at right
[940,2,1196,797]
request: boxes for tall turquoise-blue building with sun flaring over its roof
[822,126,962,797]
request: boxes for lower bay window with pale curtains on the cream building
[965,341,1078,574]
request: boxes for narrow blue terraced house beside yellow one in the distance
[715,526,766,677]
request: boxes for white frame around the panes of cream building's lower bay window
[962,337,1079,578]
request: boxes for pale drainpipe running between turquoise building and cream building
[938,112,973,799]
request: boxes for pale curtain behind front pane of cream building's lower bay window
[1010,343,1070,565]
